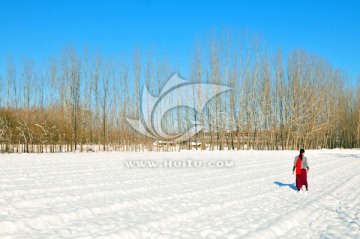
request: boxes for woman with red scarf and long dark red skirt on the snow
[293,149,310,191]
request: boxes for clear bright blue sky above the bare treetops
[0,0,360,78]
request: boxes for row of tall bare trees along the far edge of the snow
[0,32,360,153]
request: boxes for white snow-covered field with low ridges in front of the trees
[0,150,360,239]
